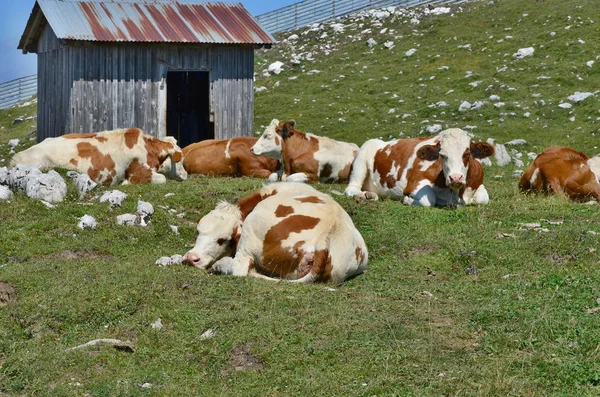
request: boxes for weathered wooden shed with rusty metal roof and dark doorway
[18,0,275,147]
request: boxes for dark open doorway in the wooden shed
[167,71,215,148]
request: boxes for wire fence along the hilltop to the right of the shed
[254,0,466,34]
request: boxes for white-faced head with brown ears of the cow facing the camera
[417,128,494,190]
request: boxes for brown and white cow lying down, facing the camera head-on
[345,128,494,207]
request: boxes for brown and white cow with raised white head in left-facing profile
[251,119,358,182]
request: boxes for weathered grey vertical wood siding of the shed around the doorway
[38,27,254,140]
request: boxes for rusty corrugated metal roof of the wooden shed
[19,0,276,48]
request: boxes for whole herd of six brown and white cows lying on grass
[11,120,600,283]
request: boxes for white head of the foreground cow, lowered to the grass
[183,201,242,269]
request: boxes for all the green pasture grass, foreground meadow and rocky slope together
[0,0,600,396]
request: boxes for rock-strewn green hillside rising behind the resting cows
[256,0,600,154]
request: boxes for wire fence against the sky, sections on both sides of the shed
[0,0,467,109]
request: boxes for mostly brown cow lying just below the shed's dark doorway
[183,137,279,181]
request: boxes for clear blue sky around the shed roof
[0,0,300,83]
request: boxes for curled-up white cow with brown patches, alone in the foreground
[184,182,368,284]
